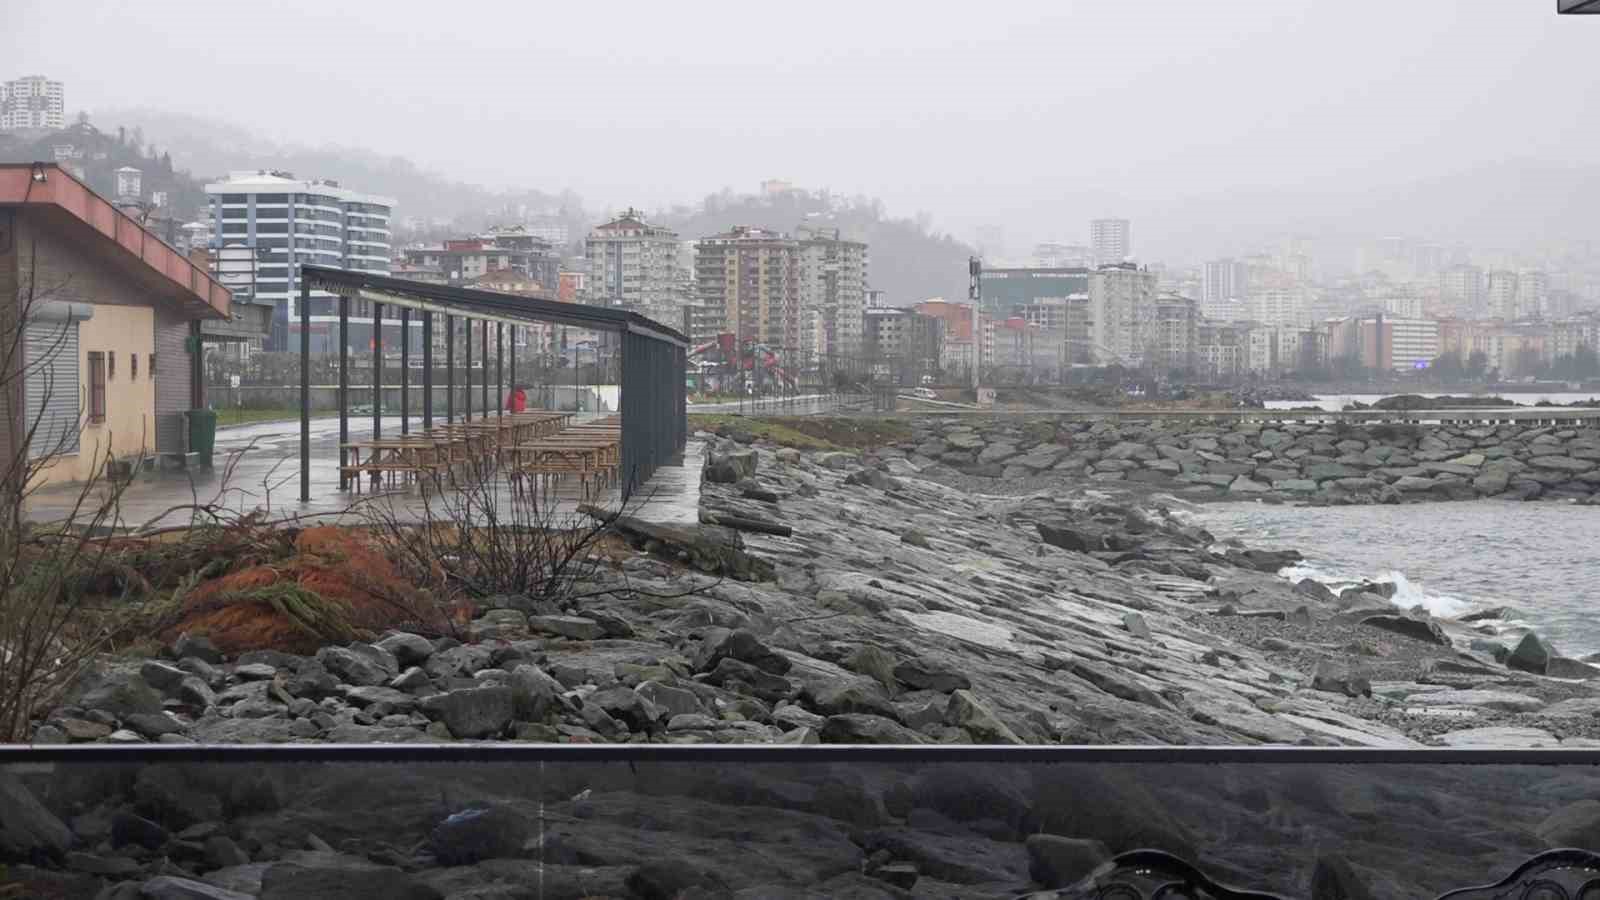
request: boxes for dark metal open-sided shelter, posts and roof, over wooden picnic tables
[299,266,688,503]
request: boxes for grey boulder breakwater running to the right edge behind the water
[896,416,1600,503]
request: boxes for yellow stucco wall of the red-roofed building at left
[37,304,155,484]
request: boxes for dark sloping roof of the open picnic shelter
[301,266,688,346]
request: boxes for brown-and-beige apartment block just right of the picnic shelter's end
[694,226,800,348]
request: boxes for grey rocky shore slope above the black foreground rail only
[34,431,1600,746]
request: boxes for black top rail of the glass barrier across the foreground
[0,743,1600,765]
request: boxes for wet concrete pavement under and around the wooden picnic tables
[27,416,701,528]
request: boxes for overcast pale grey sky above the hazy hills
[0,0,1600,257]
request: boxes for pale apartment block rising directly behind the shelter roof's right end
[584,208,683,328]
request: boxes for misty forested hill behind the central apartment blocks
[654,191,973,306]
